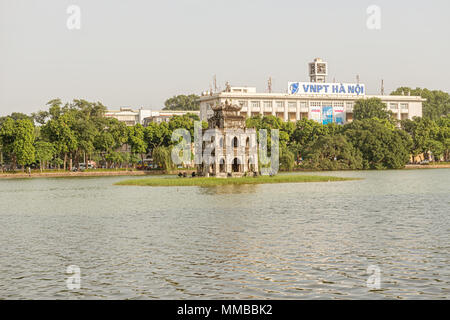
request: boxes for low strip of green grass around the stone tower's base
[116,175,357,187]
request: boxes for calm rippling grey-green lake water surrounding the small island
[0,169,450,299]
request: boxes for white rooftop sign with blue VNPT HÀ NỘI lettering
[288,82,366,96]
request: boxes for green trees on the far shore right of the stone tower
[247,98,450,170]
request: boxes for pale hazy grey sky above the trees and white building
[0,0,450,115]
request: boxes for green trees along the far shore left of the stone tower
[0,99,199,170]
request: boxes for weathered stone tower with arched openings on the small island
[195,100,258,178]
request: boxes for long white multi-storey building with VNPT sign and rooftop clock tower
[199,59,426,124]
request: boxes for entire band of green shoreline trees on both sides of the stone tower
[0,94,450,174]
